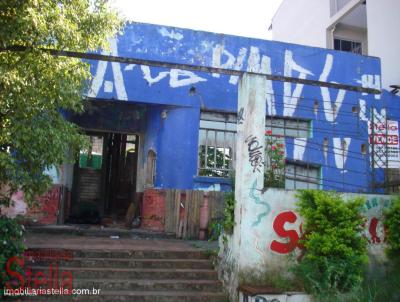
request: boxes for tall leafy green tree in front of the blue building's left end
[0,0,123,205]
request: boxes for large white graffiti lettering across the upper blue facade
[88,35,380,122]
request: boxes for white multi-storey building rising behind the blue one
[270,0,400,90]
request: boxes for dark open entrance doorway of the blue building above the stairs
[69,132,139,224]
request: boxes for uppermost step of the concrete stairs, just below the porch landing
[28,248,208,259]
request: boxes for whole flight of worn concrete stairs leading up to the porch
[23,239,229,302]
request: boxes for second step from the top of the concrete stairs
[25,257,213,269]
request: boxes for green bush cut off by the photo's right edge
[384,196,400,264]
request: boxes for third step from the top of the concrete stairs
[32,266,218,280]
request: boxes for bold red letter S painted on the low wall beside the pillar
[271,211,299,254]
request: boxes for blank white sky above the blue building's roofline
[111,0,282,39]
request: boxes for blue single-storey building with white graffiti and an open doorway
[67,23,400,219]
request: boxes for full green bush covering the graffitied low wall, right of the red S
[293,190,368,301]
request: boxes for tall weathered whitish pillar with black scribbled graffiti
[232,74,267,271]
